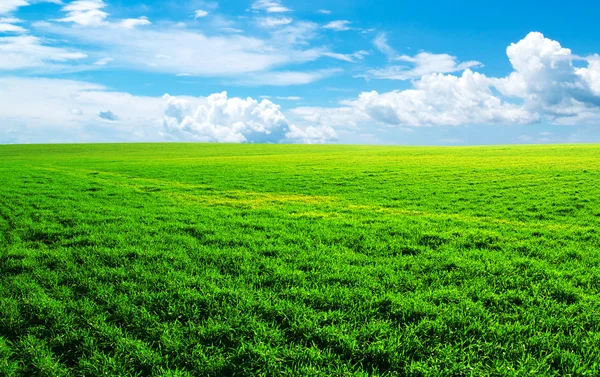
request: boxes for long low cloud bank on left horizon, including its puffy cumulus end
[0,77,335,143]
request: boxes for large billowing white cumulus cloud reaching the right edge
[292,32,600,128]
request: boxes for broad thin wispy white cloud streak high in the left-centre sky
[44,25,322,78]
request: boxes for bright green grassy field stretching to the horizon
[0,144,600,376]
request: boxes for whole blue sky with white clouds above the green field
[0,0,600,145]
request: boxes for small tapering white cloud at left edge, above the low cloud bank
[0,36,87,71]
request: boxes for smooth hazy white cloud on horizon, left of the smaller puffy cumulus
[0,77,162,143]
